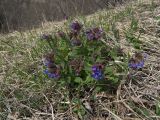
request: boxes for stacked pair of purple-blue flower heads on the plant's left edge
[43,53,60,78]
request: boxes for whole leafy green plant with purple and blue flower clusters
[39,21,144,98]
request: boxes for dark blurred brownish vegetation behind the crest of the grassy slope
[0,0,126,32]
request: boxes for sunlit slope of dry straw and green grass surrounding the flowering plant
[0,0,160,120]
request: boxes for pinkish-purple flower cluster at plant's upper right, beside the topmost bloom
[86,27,103,40]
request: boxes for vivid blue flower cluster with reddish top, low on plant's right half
[91,64,104,80]
